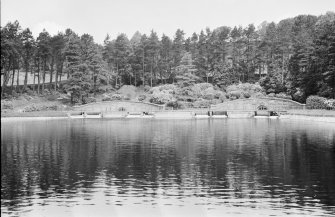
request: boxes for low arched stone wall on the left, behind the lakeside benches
[74,101,164,112]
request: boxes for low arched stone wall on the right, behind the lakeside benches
[211,97,305,111]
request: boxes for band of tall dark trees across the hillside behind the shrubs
[1,12,335,105]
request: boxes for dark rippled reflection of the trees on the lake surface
[1,119,335,211]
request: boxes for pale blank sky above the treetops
[1,0,335,43]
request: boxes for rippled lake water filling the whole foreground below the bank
[1,119,335,217]
